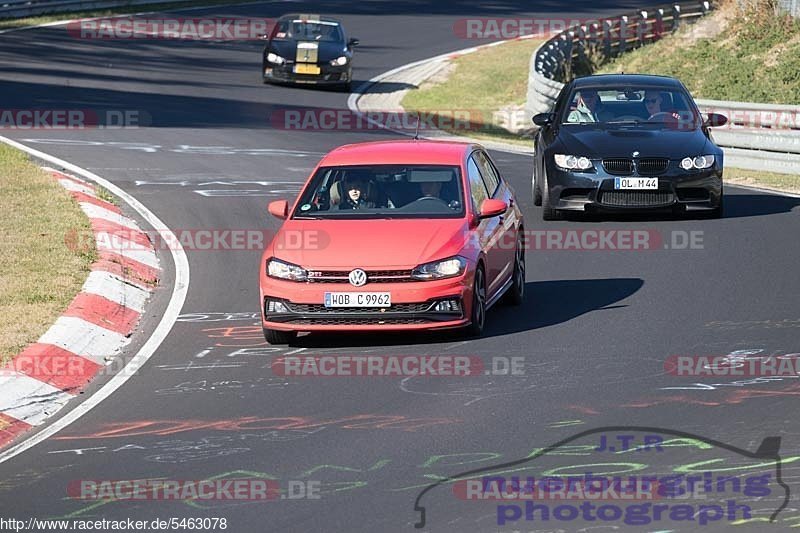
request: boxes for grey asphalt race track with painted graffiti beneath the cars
[0,0,800,532]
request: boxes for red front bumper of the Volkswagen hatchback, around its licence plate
[261,276,472,331]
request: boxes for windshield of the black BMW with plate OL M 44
[561,86,699,129]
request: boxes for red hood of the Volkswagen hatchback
[272,219,469,270]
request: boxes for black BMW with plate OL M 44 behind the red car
[533,74,727,220]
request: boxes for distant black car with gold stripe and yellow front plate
[261,15,358,90]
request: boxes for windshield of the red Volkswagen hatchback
[293,165,465,218]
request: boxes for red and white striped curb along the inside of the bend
[0,168,161,446]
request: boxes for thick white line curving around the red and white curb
[0,136,189,463]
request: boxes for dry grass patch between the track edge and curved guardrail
[402,39,541,146]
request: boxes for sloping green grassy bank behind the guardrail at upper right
[598,2,800,104]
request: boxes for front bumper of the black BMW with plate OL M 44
[547,161,722,211]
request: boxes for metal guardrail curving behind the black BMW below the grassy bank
[525,2,800,174]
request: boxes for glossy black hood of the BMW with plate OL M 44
[554,125,708,159]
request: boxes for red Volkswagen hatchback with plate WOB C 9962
[260,140,525,344]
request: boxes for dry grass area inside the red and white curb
[0,144,96,364]
